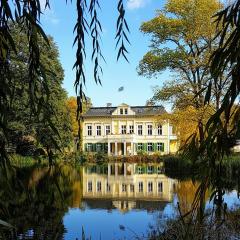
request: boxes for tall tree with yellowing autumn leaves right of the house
[138,0,227,111]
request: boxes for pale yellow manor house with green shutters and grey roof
[83,104,178,156]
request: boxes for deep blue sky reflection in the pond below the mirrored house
[63,209,158,240]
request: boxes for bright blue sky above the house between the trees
[41,0,170,106]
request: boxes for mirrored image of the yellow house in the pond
[83,163,173,211]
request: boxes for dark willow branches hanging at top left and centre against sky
[0,0,129,156]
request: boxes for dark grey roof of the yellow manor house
[83,106,166,117]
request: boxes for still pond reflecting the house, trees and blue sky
[0,163,239,240]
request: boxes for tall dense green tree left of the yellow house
[7,24,72,157]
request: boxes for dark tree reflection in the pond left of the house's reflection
[0,165,81,240]
